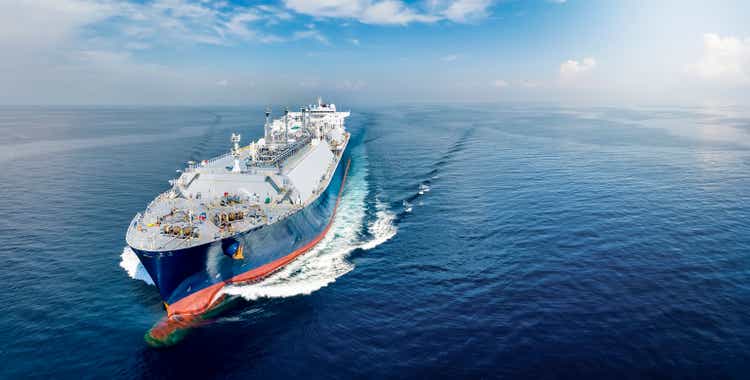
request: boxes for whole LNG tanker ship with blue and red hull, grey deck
[126,99,350,344]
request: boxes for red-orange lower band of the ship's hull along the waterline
[167,159,351,317]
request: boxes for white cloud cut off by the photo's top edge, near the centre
[284,0,494,25]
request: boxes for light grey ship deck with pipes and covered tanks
[126,110,348,252]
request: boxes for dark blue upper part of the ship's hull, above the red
[133,148,349,305]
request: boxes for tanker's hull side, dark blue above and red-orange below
[133,147,350,315]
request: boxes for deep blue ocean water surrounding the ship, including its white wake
[0,104,750,379]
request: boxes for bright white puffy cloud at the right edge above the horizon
[686,33,750,83]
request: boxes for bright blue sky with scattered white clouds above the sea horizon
[0,0,750,105]
